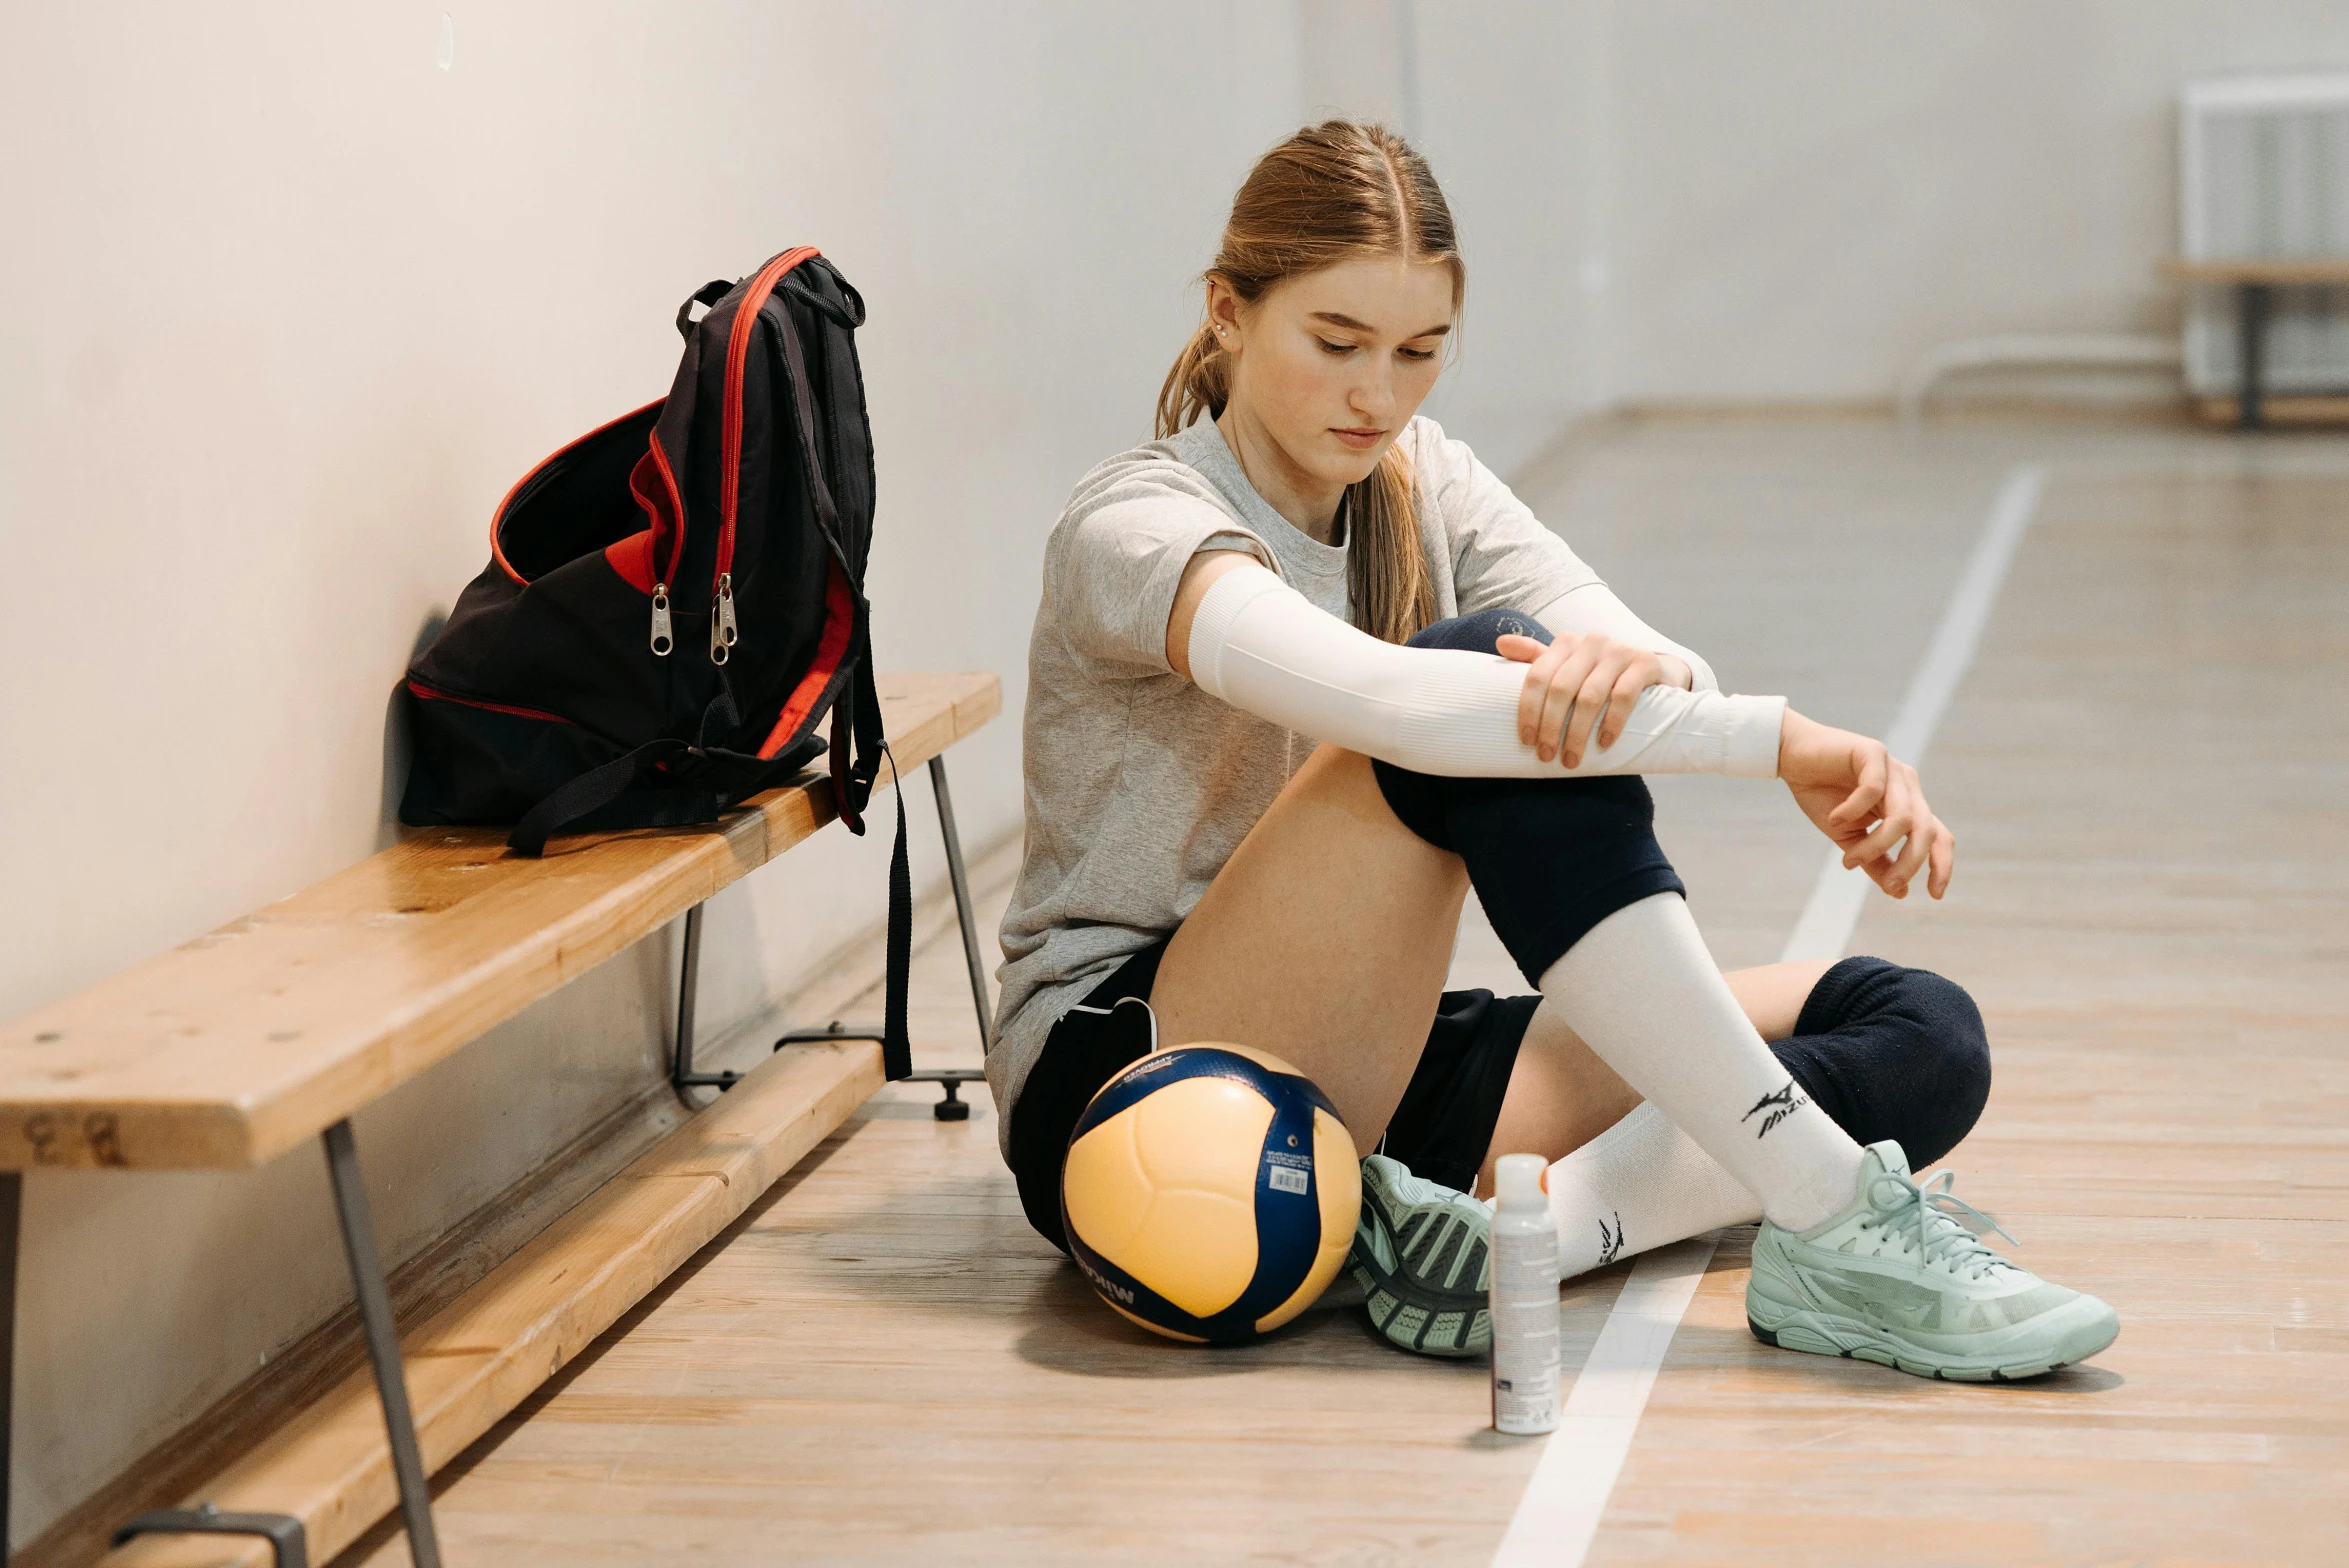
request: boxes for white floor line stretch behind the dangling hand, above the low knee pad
[1778,462,2048,962]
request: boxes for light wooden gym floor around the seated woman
[345,423,2349,1568]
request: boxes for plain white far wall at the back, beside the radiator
[1600,0,2349,404]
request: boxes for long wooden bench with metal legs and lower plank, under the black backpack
[0,674,1003,1568]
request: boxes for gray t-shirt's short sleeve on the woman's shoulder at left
[1043,460,1280,678]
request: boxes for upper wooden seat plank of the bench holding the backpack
[0,671,1003,1169]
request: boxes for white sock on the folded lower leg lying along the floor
[1548,1106,1762,1279]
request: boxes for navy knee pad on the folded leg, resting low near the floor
[1771,958,1990,1169]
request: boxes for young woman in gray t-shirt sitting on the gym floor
[987,122,2119,1380]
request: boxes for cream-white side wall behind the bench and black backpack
[0,0,1299,1545]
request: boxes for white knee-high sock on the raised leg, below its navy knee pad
[1541,892,1860,1230]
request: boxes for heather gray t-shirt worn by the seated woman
[987,418,1597,1138]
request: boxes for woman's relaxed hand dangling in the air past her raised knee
[1778,709,1957,899]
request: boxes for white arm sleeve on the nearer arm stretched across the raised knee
[1189,566,1785,779]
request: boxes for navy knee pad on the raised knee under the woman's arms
[1372,610,1687,986]
